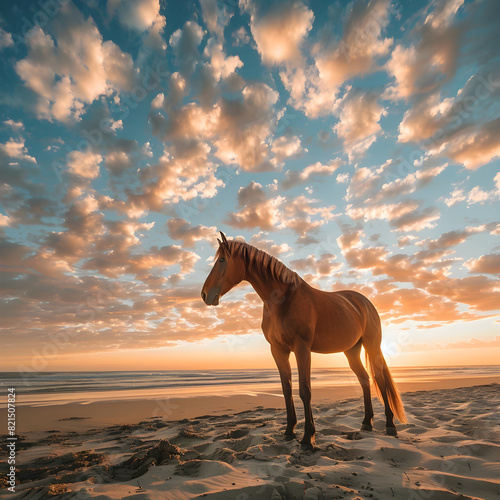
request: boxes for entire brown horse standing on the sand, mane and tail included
[201,232,406,449]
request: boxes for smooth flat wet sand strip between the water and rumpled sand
[4,375,500,433]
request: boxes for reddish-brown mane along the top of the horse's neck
[215,240,302,286]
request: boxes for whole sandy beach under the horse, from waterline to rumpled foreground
[0,379,500,500]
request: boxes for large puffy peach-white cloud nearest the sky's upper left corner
[15,3,136,122]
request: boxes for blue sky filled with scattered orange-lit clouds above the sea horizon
[0,0,500,370]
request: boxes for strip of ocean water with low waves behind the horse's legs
[0,366,500,408]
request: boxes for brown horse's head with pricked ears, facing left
[201,231,245,306]
